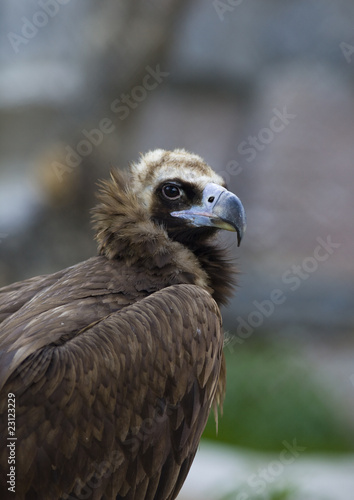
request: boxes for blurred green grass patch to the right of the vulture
[203,339,354,452]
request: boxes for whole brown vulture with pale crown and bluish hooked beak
[0,149,246,500]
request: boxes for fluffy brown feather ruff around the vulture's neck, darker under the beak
[92,170,235,304]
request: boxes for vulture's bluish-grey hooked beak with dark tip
[171,182,246,246]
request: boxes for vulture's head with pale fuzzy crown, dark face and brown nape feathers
[94,149,246,276]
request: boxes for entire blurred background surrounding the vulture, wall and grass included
[0,0,354,500]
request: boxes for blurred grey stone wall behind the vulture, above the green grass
[0,0,354,341]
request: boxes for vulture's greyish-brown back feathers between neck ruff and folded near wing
[0,257,167,389]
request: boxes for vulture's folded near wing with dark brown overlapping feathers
[0,285,223,500]
